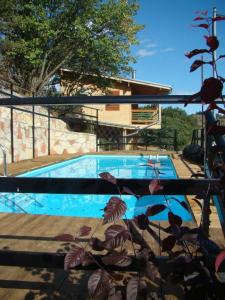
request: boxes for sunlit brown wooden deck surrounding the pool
[0,153,225,300]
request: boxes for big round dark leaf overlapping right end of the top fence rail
[200,77,223,103]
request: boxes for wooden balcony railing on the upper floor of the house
[131,108,159,125]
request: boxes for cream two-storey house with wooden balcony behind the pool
[61,69,172,150]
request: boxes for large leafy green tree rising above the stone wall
[0,0,142,92]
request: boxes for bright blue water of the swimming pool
[0,155,192,221]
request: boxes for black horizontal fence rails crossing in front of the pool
[0,95,225,268]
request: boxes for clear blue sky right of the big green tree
[132,0,225,113]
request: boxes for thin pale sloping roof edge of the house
[61,69,172,93]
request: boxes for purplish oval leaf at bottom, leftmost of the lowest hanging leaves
[88,269,110,298]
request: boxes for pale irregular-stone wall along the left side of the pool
[0,106,96,163]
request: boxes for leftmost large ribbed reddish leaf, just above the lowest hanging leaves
[64,246,86,270]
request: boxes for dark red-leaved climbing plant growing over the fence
[56,12,225,300]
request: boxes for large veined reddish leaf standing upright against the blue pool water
[103,197,127,224]
